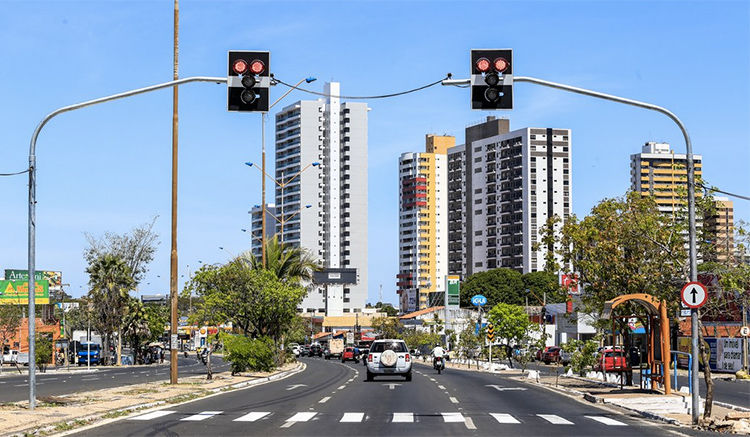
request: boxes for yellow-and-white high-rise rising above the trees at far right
[630,141,703,215]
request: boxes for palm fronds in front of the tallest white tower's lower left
[241,236,321,282]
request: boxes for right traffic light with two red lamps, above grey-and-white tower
[471,49,513,109]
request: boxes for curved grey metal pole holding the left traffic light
[27,76,227,410]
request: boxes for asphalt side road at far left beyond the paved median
[0,353,229,402]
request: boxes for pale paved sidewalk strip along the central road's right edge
[428,360,750,434]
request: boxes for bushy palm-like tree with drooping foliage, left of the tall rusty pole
[86,254,135,363]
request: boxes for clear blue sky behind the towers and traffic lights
[0,0,750,302]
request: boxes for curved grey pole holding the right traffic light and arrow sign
[442,76,700,424]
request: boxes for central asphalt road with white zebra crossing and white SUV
[76,358,716,437]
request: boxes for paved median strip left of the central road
[0,363,304,436]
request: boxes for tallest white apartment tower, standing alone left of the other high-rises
[275,82,369,316]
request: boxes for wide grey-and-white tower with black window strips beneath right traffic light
[464,117,572,275]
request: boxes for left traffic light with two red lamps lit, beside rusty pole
[227,50,271,112]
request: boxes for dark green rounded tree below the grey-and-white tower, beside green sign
[461,268,525,307]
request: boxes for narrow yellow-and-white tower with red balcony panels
[396,135,455,312]
